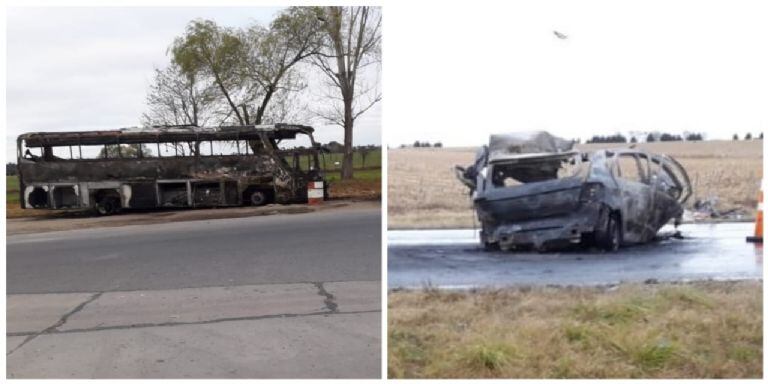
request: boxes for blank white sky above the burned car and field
[384,0,768,146]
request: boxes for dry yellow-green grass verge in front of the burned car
[388,281,763,378]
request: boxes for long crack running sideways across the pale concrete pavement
[6,309,381,336]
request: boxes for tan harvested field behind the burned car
[387,140,763,229]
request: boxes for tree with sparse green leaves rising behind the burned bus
[171,7,324,125]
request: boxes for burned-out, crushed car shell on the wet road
[456,131,692,251]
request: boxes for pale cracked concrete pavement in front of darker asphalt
[6,281,381,378]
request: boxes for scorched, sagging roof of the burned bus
[18,123,314,147]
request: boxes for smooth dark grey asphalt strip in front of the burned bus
[6,209,381,294]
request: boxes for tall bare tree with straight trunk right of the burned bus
[313,7,381,179]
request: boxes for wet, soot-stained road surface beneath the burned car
[387,223,763,289]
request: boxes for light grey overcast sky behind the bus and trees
[6,7,381,161]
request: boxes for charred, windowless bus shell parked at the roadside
[17,124,327,215]
